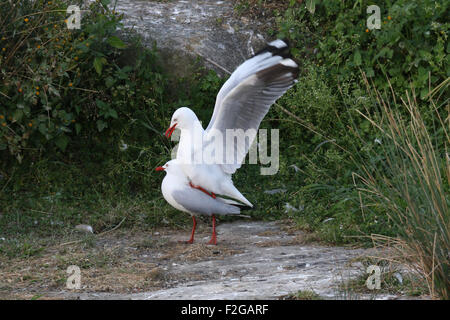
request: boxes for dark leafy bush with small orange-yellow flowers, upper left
[0,0,164,162]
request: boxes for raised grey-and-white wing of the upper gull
[206,40,299,174]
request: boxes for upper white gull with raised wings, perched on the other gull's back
[162,40,299,241]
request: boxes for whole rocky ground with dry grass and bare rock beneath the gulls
[0,221,408,299]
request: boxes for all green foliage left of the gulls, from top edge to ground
[0,1,179,240]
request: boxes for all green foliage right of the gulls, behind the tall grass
[269,0,450,248]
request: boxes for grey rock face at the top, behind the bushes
[115,0,268,74]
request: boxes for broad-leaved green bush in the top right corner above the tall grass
[278,0,450,99]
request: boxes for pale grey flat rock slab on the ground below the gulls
[57,221,402,300]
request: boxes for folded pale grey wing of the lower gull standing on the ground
[172,187,241,216]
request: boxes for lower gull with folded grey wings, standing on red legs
[156,159,241,245]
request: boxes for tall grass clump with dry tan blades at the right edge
[358,79,450,299]
